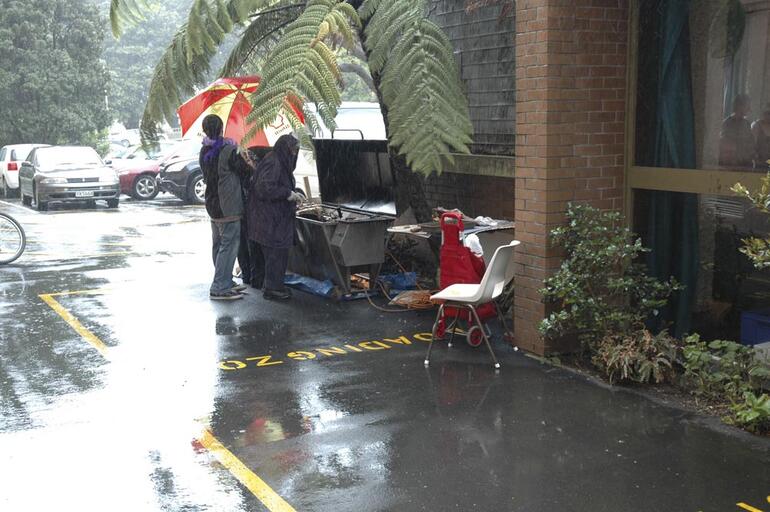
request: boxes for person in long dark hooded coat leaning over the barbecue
[247,135,303,300]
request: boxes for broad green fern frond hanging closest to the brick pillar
[360,0,473,174]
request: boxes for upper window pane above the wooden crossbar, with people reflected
[635,0,770,172]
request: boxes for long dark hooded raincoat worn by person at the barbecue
[248,135,299,249]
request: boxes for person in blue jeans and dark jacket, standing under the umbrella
[199,114,252,300]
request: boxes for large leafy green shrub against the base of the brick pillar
[540,204,678,351]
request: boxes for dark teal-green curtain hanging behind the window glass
[639,0,699,337]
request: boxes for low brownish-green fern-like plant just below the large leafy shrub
[592,329,677,383]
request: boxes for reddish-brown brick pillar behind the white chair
[514,0,628,355]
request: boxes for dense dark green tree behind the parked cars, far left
[0,0,110,144]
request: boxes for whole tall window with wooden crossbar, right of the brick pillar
[627,0,770,340]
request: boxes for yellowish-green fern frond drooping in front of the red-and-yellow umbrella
[247,0,360,148]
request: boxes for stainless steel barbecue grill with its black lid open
[289,139,396,296]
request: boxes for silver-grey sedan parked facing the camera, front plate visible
[19,146,120,210]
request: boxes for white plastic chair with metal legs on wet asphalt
[425,240,521,370]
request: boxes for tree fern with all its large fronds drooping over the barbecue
[110,0,473,174]
